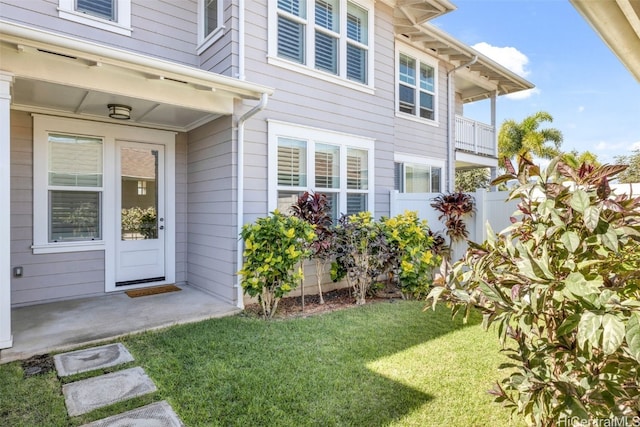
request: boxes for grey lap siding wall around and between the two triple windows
[244,1,395,223]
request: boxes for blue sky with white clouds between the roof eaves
[431,0,640,163]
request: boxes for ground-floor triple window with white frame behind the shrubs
[269,122,374,220]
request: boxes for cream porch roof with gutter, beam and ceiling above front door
[0,22,272,131]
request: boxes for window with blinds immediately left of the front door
[47,134,103,242]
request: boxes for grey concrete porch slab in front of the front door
[0,285,239,363]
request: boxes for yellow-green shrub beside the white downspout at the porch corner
[238,210,315,318]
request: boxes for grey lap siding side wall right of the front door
[187,116,237,303]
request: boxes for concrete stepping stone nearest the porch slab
[53,343,133,377]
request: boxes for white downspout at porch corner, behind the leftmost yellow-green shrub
[236,93,269,309]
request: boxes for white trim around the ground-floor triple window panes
[267,120,376,216]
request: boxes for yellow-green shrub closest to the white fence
[382,211,441,298]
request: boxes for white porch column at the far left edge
[0,71,13,349]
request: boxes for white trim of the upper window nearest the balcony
[394,41,440,127]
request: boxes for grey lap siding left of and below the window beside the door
[10,111,104,305]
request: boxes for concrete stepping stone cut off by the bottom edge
[81,400,184,427]
